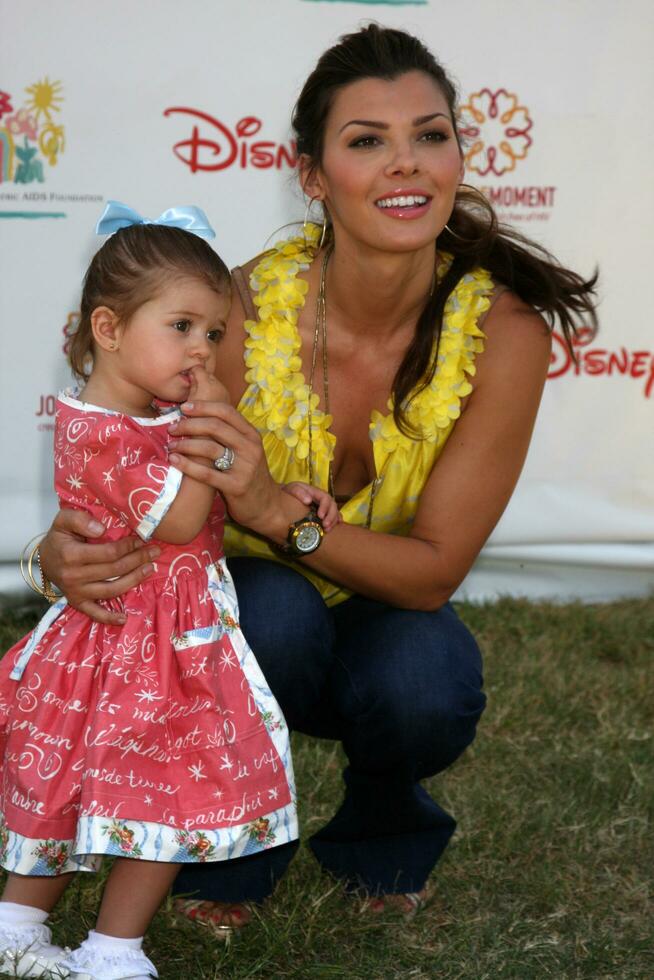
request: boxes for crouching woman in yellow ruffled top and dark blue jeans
[41,25,595,927]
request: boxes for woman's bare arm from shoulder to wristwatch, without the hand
[300,294,550,609]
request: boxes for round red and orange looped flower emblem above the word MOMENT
[459,88,533,177]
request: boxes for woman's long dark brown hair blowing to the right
[293,24,597,437]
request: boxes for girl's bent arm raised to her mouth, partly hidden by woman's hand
[153,366,229,544]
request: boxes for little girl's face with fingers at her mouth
[120,278,230,402]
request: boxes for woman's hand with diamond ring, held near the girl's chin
[169,401,302,543]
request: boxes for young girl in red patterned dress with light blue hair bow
[0,202,336,980]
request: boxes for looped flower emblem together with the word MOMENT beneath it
[459,88,556,222]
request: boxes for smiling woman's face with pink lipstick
[305,71,463,252]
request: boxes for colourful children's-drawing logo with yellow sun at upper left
[0,77,64,184]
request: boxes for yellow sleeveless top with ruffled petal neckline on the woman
[225,225,494,605]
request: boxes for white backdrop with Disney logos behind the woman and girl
[0,0,654,599]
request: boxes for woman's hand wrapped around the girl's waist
[39,510,160,626]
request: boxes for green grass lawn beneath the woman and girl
[0,598,654,980]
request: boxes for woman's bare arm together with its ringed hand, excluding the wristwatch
[171,293,551,609]
